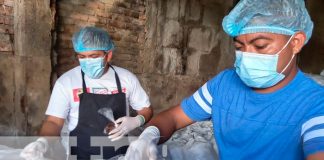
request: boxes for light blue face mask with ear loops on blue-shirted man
[234,35,295,88]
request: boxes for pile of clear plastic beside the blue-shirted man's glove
[159,121,218,160]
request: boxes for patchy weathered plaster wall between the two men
[139,0,233,112]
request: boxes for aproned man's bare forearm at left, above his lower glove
[39,116,64,136]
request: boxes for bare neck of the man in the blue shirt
[254,66,298,93]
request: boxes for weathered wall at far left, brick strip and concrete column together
[0,0,51,135]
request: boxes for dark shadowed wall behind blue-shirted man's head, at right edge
[299,0,324,74]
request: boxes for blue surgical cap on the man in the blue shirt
[222,0,313,44]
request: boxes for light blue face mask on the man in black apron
[79,57,106,79]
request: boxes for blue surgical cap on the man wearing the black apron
[72,27,115,53]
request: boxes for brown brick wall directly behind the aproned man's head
[53,0,145,76]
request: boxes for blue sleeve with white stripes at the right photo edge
[301,100,324,157]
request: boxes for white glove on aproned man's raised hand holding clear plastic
[108,115,145,141]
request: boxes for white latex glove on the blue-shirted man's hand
[125,126,160,160]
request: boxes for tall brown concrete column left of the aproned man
[12,0,52,135]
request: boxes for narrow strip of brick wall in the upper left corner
[0,0,14,54]
